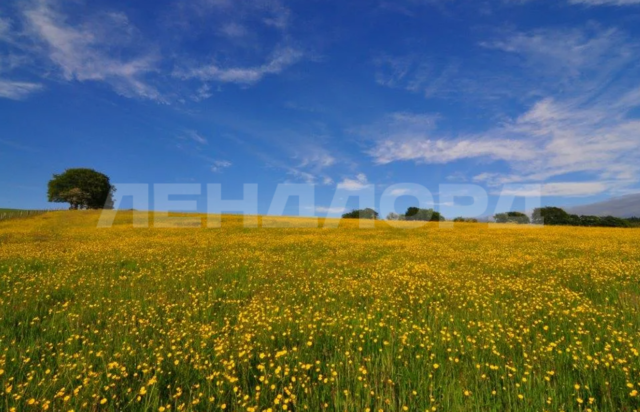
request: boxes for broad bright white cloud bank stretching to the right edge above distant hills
[369,95,640,190]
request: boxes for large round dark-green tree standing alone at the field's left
[48,169,115,210]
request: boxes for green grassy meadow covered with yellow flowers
[0,211,640,411]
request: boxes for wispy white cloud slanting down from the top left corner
[23,0,163,101]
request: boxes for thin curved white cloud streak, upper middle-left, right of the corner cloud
[173,47,303,84]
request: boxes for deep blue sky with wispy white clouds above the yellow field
[0,0,640,217]
